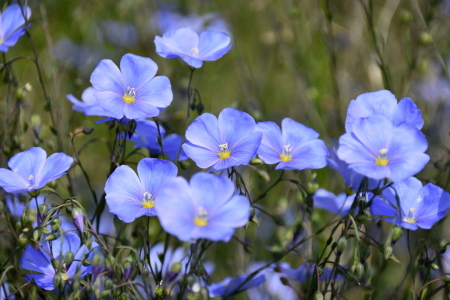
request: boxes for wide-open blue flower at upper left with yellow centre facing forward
[91,54,173,119]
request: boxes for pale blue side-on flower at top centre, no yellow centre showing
[155,27,231,69]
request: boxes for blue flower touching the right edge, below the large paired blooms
[370,177,450,230]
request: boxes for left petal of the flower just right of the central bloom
[255,122,283,164]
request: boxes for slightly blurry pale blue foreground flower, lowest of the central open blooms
[155,173,250,242]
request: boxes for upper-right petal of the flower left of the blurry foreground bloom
[137,158,178,197]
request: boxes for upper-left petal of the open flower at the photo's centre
[186,113,221,150]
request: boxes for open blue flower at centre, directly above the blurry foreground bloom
[183,108,262,171]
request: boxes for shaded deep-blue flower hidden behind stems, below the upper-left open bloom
[130,120,188,161]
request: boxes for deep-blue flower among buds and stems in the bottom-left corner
[20,232,97,290]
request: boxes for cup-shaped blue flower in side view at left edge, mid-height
[0,147,73,193]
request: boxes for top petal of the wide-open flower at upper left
[120,53,158,91]
